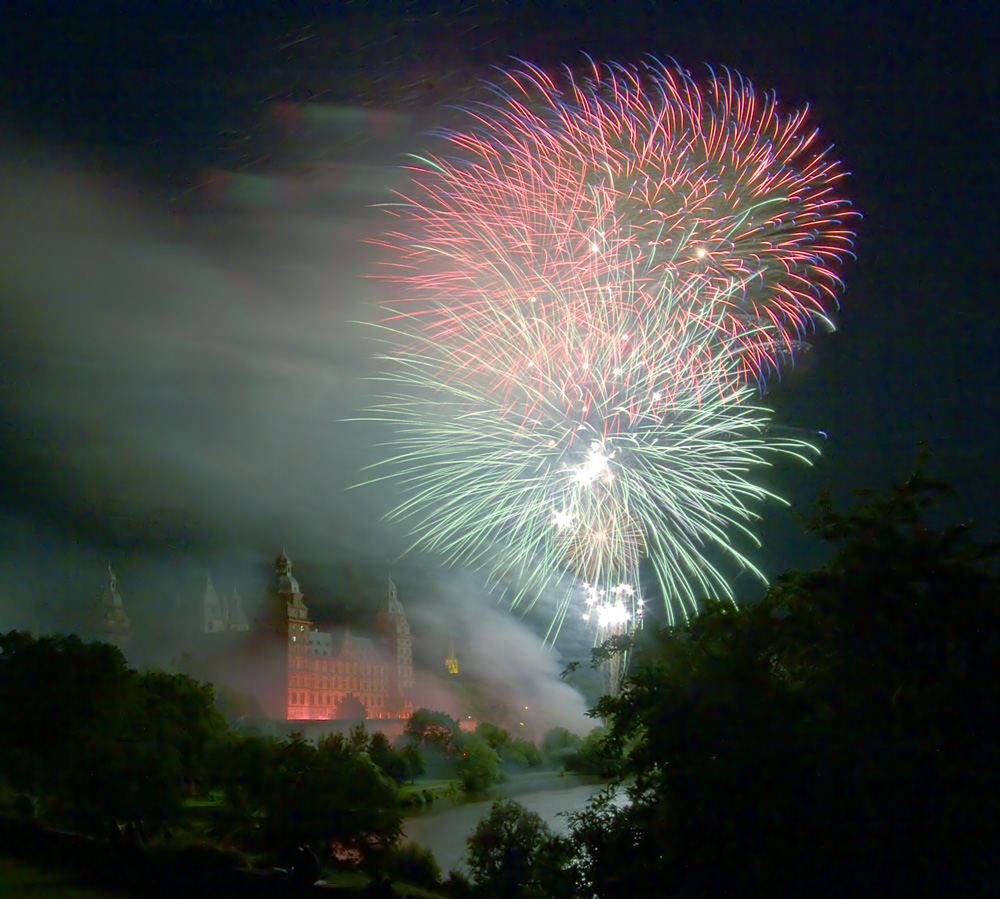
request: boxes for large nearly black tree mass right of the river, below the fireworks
[563,474,1000,899]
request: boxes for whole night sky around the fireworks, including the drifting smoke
[0,0,1000,704]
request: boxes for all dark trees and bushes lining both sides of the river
[0,469,1000,899]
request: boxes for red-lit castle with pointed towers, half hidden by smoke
[91,552,414,721]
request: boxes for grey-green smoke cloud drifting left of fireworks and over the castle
[0,126,588,730]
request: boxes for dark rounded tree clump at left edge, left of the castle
[0,632,211,834]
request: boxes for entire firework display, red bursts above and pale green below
[364,62,853,676]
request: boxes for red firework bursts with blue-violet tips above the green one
[378,65,851,400]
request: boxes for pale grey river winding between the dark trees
[403,773,604,876]
